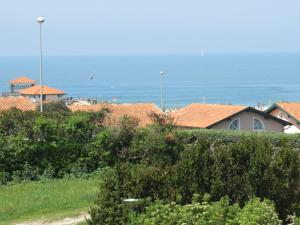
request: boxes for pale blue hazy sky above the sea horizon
[0,0,300,56]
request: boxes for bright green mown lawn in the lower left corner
[0,177,99,225]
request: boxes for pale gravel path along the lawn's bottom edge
[16,213,89,225]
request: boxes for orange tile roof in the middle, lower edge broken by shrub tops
[69,103,163,127]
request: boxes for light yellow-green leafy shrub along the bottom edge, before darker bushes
[127,198,281,225]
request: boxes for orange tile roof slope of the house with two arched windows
[170,104,248,128]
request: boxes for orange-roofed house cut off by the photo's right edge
[265,102,300,134]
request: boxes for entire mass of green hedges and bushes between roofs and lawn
[0,104,300,225]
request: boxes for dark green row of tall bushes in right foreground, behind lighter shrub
[91,135,300,224]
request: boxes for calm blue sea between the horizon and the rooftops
[0,53,300,107]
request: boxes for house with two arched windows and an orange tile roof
[170,104,290,132]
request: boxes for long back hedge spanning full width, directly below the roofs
[0,108,300,184]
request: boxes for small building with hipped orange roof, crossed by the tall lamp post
[20,86,65,102]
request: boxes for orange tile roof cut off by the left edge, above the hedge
[0,96,36,111]
